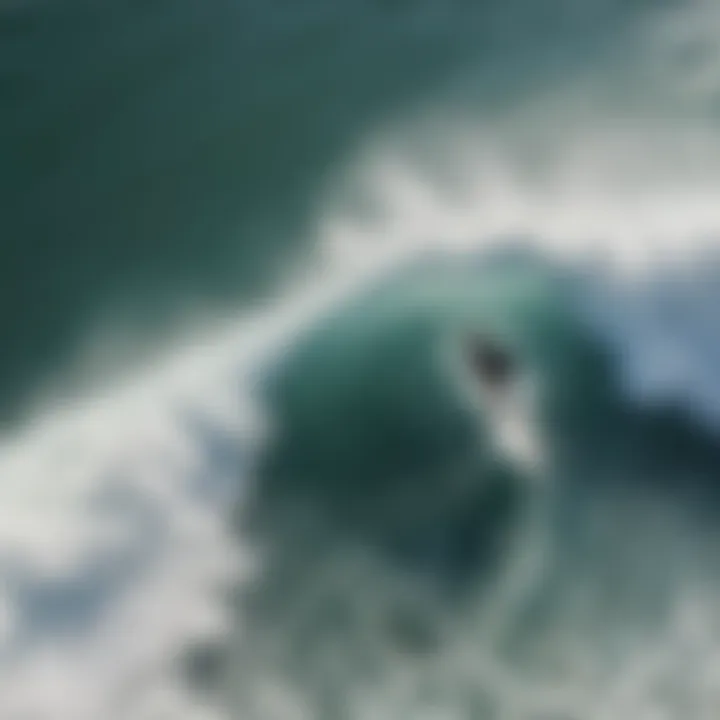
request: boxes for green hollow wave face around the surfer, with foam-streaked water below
[225,252,720,718]
